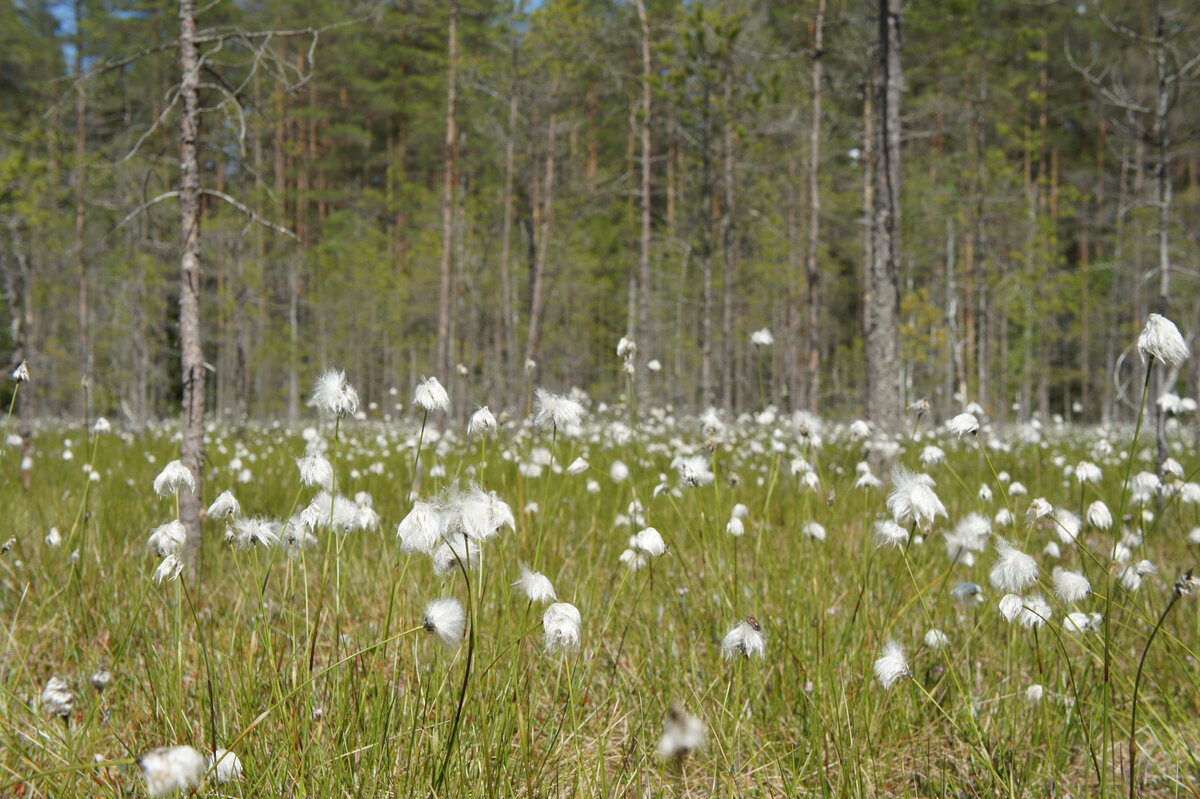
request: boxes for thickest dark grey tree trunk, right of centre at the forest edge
[865,0,904,432]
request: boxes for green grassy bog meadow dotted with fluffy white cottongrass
[0,369,1200,799]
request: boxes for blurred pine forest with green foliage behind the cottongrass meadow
[0,0,1200,425]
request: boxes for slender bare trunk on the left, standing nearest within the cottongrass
[179,0,204,572]
